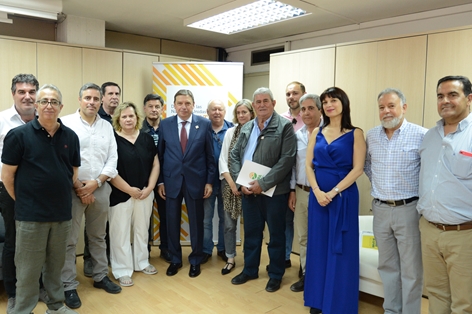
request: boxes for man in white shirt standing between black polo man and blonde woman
[62,83,121,309]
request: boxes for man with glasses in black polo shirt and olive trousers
[2,85,80,314]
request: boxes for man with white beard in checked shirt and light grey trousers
[364,88,427,313]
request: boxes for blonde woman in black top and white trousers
[108,102,159,287]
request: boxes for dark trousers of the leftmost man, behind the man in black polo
[0,182,16,298]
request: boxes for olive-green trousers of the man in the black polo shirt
[15,220,71,314]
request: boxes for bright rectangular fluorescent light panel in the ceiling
[187,0,311,35]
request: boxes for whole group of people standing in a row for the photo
[0,74,472,314]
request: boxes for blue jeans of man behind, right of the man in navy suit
[203,184,225,255]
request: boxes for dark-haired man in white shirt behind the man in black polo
[0,74,48,314]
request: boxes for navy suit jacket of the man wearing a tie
[158,114,217,199]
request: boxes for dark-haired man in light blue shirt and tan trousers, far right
[417,76,472,314]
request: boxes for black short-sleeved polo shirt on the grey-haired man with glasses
[2,119,80,222]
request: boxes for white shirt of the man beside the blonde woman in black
[61,110,118,181]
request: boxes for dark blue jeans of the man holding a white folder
[242,193,288,280]
